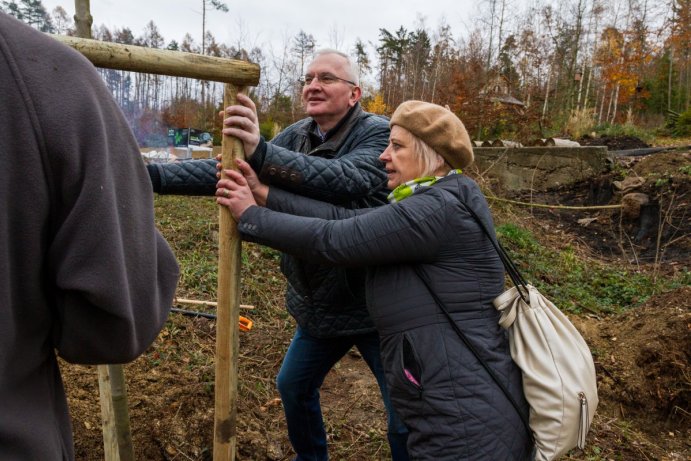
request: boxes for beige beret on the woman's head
[389,101,473,168]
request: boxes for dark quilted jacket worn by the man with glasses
[148,104,389,337]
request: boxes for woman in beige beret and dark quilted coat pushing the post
[216,101,532,461]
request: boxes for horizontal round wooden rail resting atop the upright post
[51,35,259,85]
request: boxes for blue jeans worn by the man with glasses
[276,327,409,461]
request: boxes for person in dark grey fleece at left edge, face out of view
[0,13,178,461]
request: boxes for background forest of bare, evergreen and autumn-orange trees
[5,0,691,147]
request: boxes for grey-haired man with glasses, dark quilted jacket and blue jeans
[149,50,408,461]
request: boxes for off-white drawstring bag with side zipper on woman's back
[494,284,598,461]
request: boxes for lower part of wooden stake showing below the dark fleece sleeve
[98,365,134,461]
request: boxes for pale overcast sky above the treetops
[43,0,481,55]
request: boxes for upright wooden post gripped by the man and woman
[214,83,245,461]
